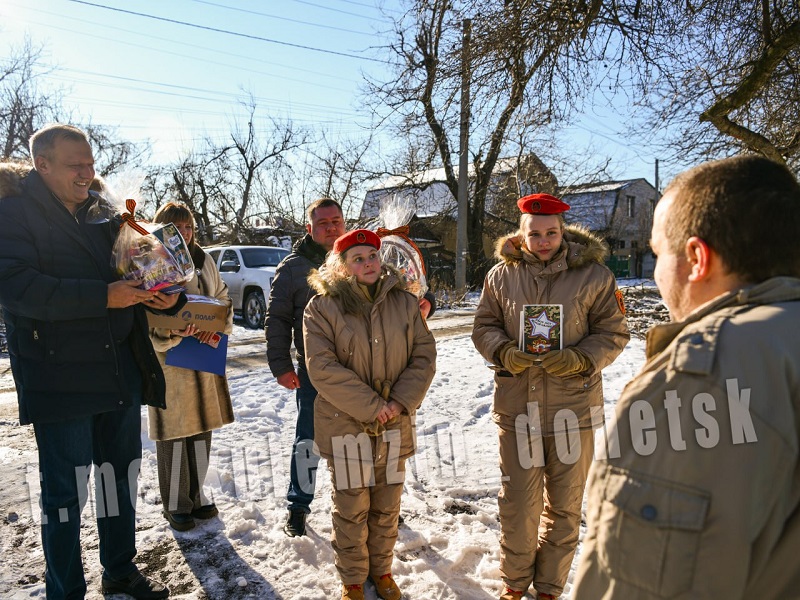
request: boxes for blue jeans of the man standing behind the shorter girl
[286,365,319,512]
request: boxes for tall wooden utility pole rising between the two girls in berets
[456,19,472,292]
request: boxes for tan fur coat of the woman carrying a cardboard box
[148,251,233,441]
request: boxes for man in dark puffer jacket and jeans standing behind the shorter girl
[265,198,345,537]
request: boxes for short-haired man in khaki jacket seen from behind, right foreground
[573,156,800,600]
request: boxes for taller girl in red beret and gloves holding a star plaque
[472,194,630,600]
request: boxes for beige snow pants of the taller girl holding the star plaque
[495,414,594,596]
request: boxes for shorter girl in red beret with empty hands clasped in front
[303,229,436,600]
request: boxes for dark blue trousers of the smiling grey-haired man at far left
[33,404,142,600]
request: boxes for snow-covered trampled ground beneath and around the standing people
[0,282,647,600]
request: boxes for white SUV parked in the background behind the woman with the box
[206,246,289,329]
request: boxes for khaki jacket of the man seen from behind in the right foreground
[574,277,800,600]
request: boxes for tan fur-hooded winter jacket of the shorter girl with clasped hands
[303,265,436,458]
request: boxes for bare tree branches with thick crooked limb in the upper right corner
[594,0,800,168]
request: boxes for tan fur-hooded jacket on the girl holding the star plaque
[472,225,630,435]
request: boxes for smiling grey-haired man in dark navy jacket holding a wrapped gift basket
[0,125,180,598]
